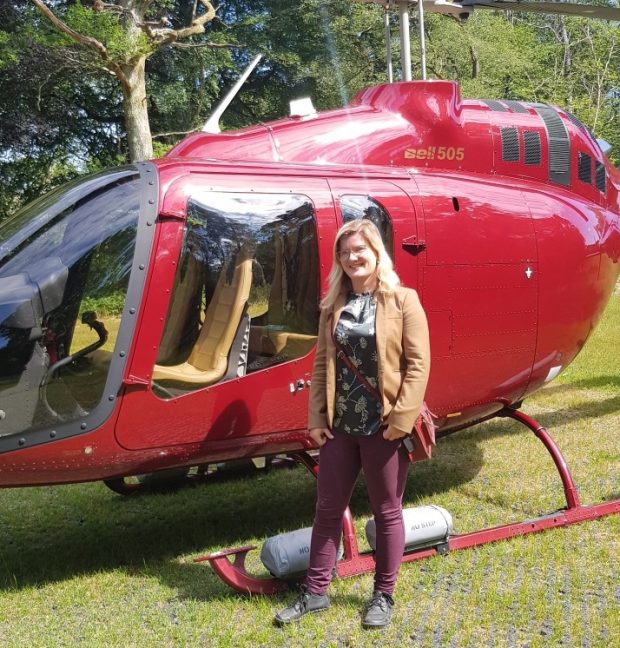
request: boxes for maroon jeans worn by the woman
[306,430,409,594]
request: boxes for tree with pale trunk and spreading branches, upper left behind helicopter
[32,0,215,161]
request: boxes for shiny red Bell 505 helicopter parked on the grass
[0,2,620,593]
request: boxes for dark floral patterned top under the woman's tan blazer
[333,292,383,436]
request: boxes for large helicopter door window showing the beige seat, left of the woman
[153,192,319,398]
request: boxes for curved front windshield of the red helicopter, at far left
[0,167,140,437]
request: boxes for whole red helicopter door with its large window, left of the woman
[116,173,336,462]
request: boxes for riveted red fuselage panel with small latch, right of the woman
[416,175,539,427]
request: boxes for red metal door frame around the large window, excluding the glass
[116,169,336,455]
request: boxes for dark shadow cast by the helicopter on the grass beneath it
[0,390,620,604]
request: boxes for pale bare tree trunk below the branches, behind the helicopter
[122,56,153,162]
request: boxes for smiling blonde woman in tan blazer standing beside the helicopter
[275,220,430,627]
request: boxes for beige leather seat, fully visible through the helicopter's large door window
[153,249,252,386]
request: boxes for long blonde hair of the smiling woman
[321,219,400,308]
